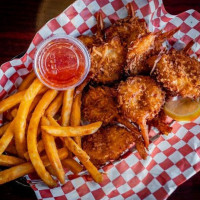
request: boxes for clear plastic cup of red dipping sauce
[34,35,90,90]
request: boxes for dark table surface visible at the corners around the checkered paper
[0,0,200,200]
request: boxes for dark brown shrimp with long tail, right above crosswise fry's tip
[82,86,147,159]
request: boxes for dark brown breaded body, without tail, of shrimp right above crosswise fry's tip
[82,86,118,125]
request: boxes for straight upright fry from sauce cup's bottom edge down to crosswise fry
[61,88,74,126]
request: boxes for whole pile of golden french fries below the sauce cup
[0,72,102,187]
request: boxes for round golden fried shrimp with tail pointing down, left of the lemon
[118,76,165,148]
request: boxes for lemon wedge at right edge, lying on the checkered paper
[164,98,200,121]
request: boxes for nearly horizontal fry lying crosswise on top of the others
[41,122,102,137]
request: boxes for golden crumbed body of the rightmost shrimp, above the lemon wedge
[148,50,200,98]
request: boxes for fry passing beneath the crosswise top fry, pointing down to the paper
[41,117,65,184]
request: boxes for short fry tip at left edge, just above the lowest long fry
[0,155,24,167]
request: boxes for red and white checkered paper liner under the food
[0,0,200,200]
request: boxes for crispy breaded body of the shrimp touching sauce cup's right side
[90,36,125,84]
